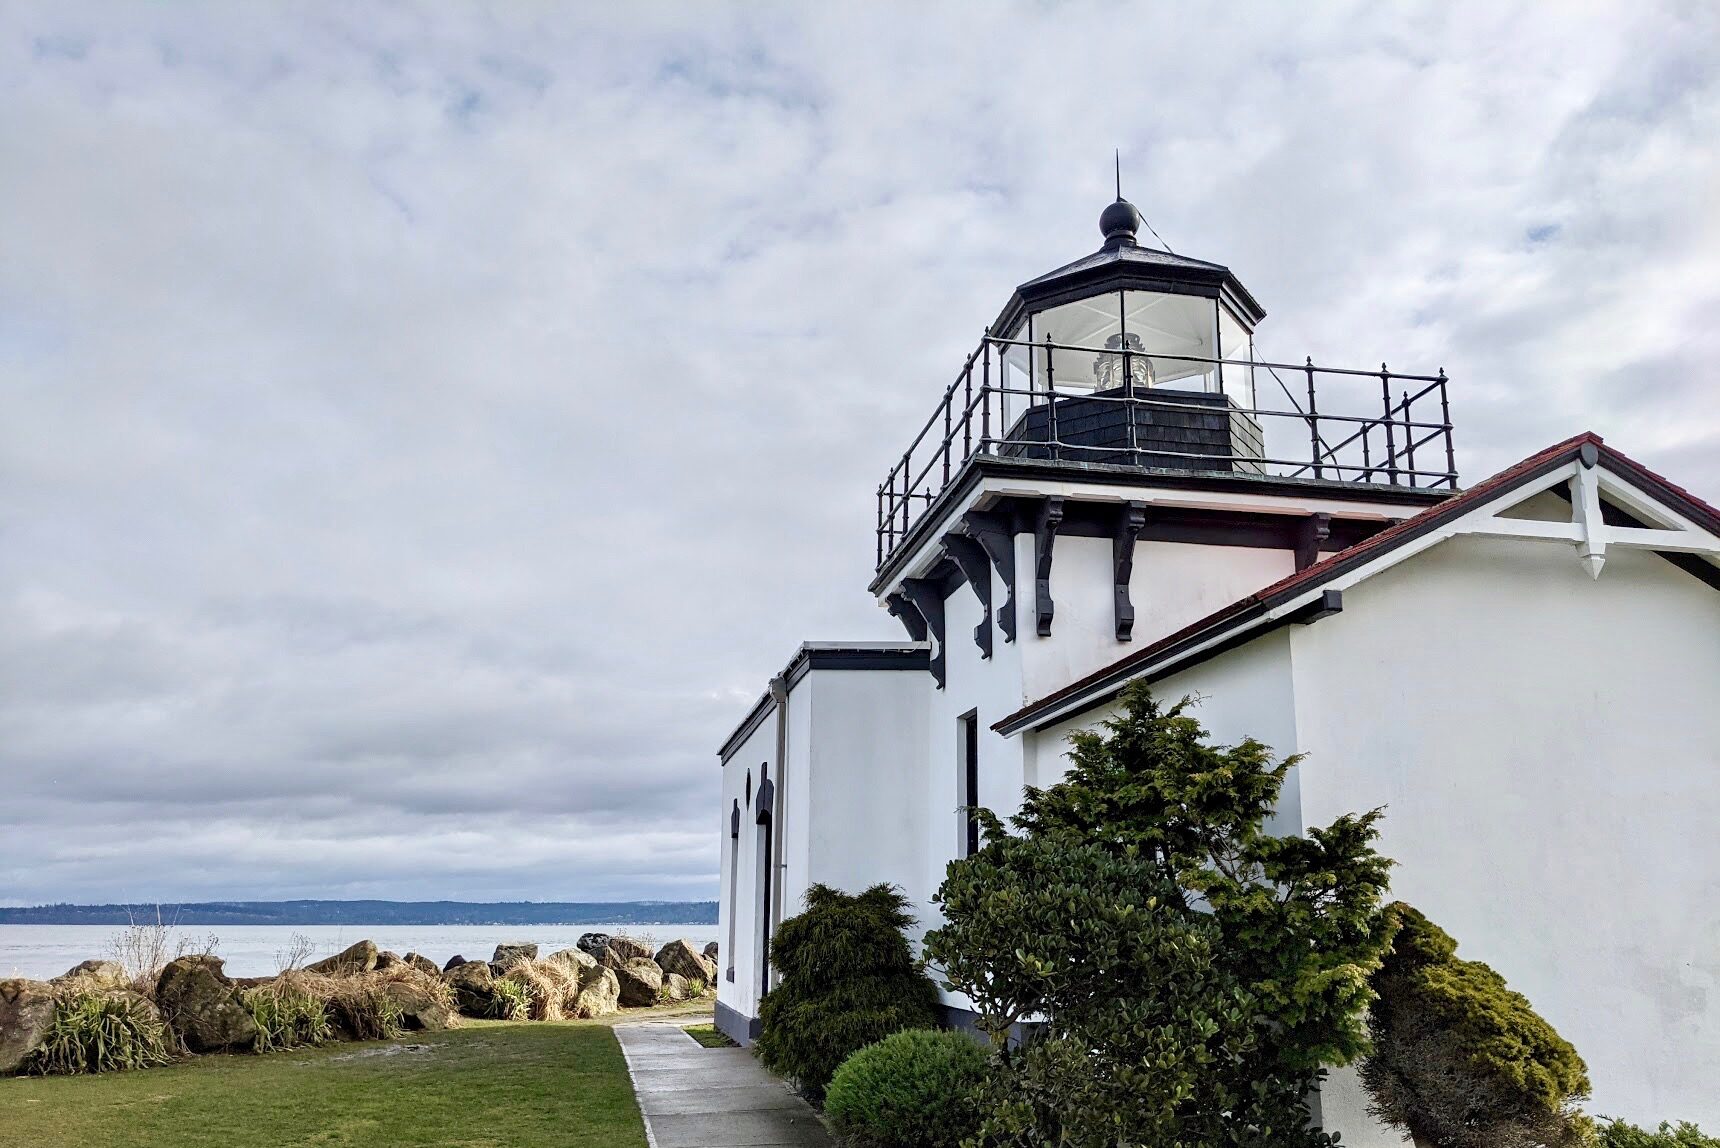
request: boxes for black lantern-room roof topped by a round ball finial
[992,198,1266,337]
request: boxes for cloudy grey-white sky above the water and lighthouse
[0,0,1720,904]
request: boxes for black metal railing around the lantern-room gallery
[877,336,1457,566]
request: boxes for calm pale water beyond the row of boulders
[0,924,717,979]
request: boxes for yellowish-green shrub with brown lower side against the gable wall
[1361,902,1589,1148]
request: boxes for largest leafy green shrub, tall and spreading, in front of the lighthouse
[925,683,1390,1148]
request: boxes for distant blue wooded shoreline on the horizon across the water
[0,900,717,926]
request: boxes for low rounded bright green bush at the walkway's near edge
[824,1029,986,1148]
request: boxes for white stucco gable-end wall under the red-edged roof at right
[1290,537,1720,1148]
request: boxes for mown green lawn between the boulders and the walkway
[0,1021,645,1148]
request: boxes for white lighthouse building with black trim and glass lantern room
[717,200,1720,1148]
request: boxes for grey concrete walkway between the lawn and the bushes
[616,1021,831,1148]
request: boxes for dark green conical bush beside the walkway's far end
[757,885,939,1096]
